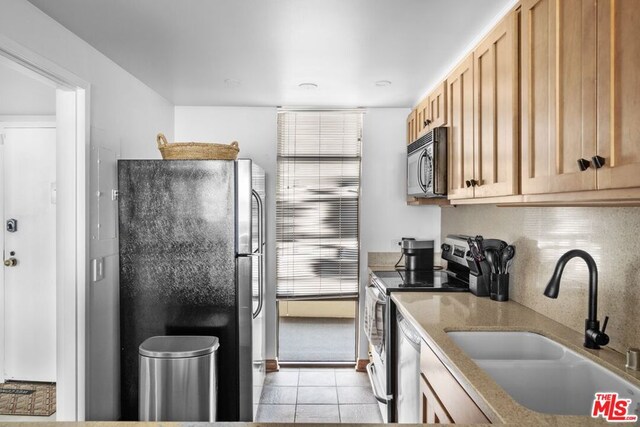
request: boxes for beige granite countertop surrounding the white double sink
[392,292,640,426]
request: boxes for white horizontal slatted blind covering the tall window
[276,111,362,299]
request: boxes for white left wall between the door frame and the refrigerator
[0,0,173,420]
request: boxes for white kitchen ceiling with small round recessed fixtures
[29,0,513,107]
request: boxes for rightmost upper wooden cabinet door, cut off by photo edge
[597,0,640,189]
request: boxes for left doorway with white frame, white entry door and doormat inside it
[0,35,89,421]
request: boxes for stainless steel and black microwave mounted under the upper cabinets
[407,127,447,198]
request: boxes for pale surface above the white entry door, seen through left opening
[0,62,56,116]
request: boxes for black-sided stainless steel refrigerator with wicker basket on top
[118,159,266,421]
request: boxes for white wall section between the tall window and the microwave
[358,108,440,359]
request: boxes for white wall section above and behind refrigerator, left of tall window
[175,107,277,359]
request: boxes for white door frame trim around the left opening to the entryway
[0,34,90,421]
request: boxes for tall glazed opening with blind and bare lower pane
[276,109,364,365]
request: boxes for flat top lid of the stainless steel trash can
[139,335,220,359]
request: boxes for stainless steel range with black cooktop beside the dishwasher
[364,235,480,423]
